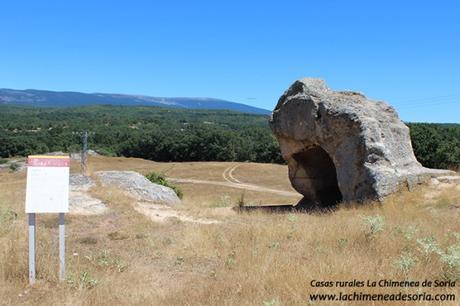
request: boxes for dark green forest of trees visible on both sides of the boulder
[0,105,460,168]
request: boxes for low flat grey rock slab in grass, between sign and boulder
[96,171,181,206]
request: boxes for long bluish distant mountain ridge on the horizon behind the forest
[0,89,270,115]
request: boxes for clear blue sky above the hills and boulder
[0,0,460,123]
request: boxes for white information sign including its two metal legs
[26,156,70,284]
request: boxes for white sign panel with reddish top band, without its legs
[26,156,70,213]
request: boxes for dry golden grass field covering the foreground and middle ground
[0,157,460,305]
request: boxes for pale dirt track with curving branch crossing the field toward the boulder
[168,165,299,197]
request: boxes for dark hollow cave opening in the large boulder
[293,146,342,206]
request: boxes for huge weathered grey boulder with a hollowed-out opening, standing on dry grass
[270,78,449,206]
